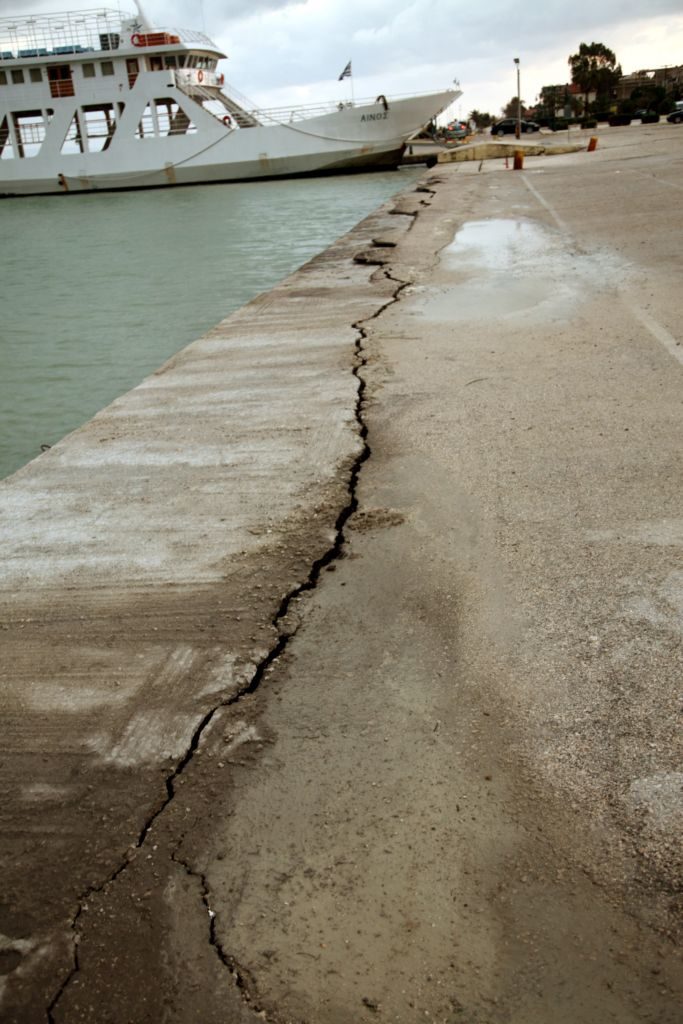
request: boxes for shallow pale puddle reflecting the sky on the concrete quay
[416,218,600,323]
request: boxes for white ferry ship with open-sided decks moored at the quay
[0,3,461,196]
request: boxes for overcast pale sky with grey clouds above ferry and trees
[5,0,683,117]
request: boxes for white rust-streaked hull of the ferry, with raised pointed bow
[0,90,457,197]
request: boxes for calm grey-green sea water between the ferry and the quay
[0,169,420,477]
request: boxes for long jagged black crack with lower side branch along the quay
[46,234,419,1024]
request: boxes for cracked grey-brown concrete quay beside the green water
[0,125,683,1024]
